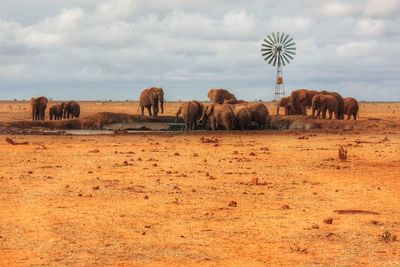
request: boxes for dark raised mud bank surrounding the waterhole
[0,112,400,134]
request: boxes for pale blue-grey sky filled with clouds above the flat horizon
[0,0,400,101]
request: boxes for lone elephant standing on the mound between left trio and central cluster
[139,87,164,117]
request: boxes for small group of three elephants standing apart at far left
[31,96,81,121]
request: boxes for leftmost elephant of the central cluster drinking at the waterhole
[175,100,205,131]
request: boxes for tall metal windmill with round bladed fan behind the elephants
[261,32,296,101]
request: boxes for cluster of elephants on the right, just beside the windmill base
[276,89,359,120]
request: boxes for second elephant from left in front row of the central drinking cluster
[198,103,235,131]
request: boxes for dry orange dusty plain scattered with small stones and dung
[0,102,400,266]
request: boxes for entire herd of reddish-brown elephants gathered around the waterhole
[31,87,359,130]
